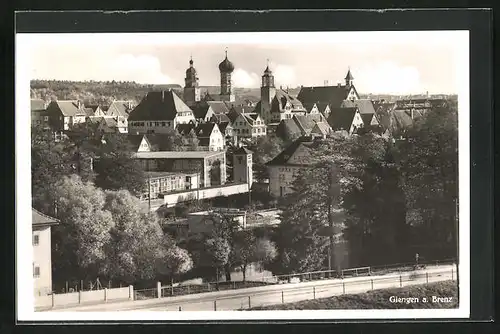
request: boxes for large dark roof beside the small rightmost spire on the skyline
[297,85,349,108]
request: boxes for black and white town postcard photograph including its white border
[16,22,470,321]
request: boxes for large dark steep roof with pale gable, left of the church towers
[129,90,192,121]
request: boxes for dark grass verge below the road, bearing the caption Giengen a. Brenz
[250,281,458,310]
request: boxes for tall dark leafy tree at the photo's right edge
[399,104,458,257]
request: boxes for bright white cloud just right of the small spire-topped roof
[351,62,424,94]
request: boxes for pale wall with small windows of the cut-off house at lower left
[33,226,52,296]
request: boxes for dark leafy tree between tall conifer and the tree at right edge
[343,134,409,265]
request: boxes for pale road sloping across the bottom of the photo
[49,265,456,312]
